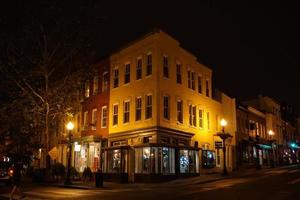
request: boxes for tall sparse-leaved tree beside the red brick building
[0,1,105,166]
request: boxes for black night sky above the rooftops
[0,0,300,111]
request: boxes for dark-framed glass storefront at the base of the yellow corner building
[103,144,199,182]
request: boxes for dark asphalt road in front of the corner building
[0,166,300,200]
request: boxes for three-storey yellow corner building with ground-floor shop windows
[103,30,236,181]
